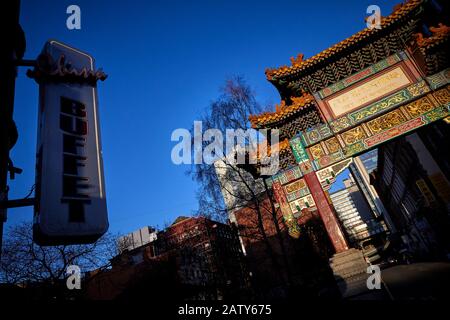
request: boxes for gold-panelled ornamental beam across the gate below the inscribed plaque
[268,84,450,192]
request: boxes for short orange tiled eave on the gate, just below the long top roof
[249,94,314,128]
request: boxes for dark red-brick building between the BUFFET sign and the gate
[87,217,249,300]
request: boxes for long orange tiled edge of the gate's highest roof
[266,0,423,80]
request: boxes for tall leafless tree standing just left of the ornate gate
[188,77,291,283]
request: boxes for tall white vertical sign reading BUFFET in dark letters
[29,41,108,245]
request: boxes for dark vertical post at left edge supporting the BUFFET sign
[0,0,25,259]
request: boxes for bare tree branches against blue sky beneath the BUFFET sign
[0,223,117,284]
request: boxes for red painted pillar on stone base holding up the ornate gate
[304,171,348,253]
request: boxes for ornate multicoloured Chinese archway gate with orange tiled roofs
[250,1,450,252]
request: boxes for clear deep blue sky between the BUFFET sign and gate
[6,0,399,233]
